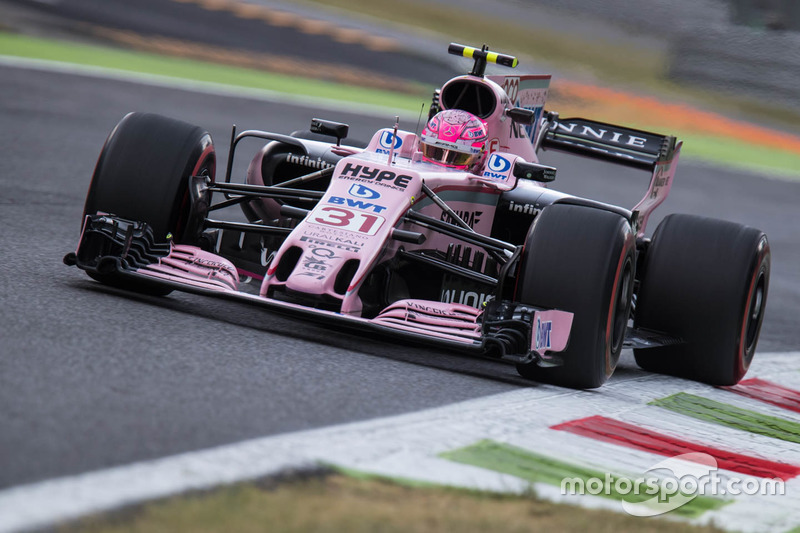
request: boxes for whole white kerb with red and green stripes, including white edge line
[0,352,800,531]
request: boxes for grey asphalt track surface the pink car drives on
[0,63,800,488]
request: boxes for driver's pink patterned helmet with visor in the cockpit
[419,109,489,169]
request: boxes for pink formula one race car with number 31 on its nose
[64,44,770,388]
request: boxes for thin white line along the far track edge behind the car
[0,55,422,122]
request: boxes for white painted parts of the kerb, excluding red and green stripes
[0,352,800,531]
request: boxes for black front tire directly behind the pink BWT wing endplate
[516,204,636,388]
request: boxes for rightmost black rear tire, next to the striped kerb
[634,215,770,385]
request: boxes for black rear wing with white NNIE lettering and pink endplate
[539,118,682,238]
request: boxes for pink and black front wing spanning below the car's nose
[64,214,573,366]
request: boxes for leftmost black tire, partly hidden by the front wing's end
[83,113,216,294]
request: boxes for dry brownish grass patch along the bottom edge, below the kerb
[69,475,718,533]
